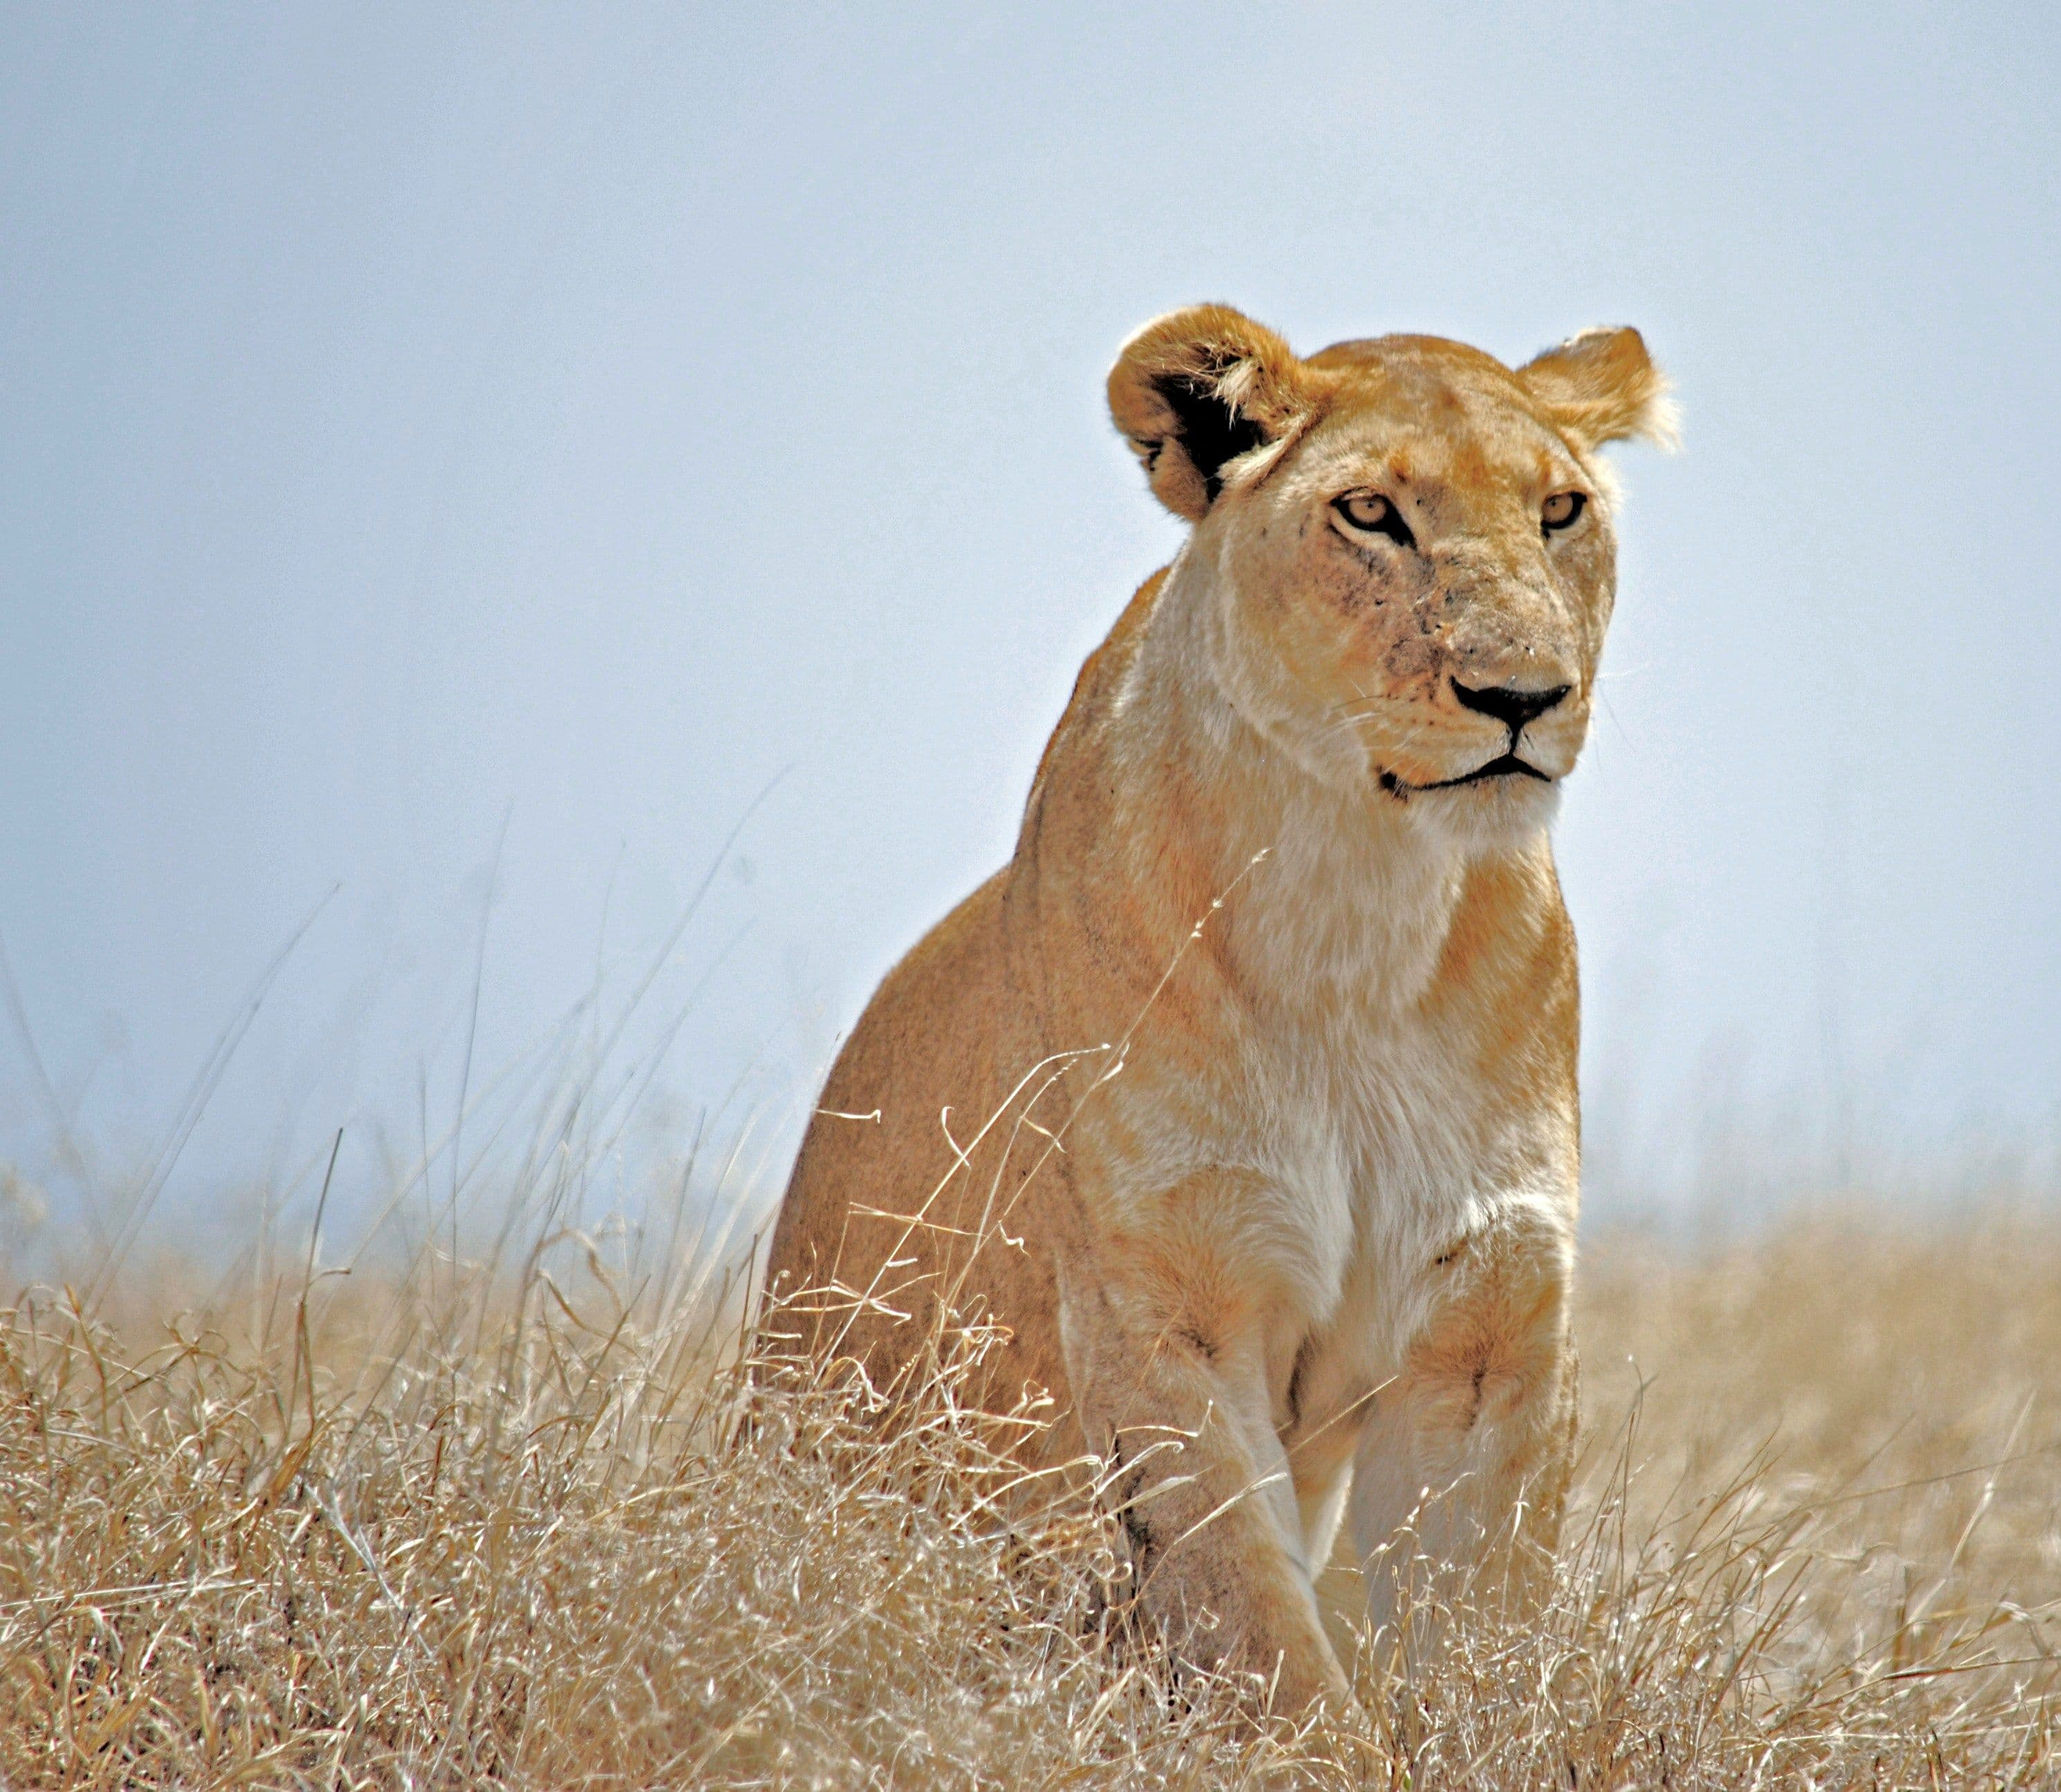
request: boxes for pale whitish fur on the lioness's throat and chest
[1119,785,1574,1376]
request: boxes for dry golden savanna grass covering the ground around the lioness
[0,1211,2061,1788]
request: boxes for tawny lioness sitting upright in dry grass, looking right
[769,305,1667,1708]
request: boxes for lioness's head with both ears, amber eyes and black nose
[1109,305,1669,836]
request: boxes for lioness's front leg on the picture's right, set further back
[1350,1225,1574,1646]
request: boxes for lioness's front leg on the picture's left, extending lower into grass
[1062,1265,1350,1712]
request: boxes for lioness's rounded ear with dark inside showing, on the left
[1109,305,1309,521]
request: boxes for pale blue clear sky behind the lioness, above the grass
[0,0,2061,1236]
